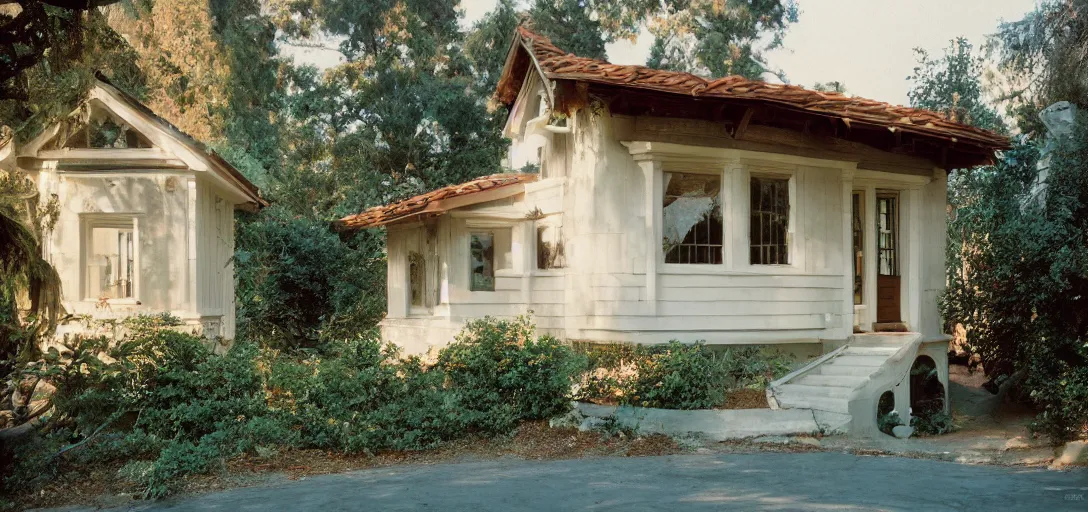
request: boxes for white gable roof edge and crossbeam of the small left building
[14,73,269,208]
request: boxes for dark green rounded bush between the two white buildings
[234,205,385,348]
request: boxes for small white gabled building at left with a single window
[5,76,267,339]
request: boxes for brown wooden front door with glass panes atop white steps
[877,193,903,323]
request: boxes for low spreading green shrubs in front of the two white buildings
[4,319,580,498]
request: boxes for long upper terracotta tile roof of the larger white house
[496,26,1009,151]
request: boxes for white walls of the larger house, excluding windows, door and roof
[382,87,945,352]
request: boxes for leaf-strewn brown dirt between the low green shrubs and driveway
[6,421,683,510]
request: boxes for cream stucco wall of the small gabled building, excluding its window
[44,171,235,338]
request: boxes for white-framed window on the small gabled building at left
[84,218,138,300]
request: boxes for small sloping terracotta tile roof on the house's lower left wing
[336,174,537,229]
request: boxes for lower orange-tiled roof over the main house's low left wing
[336,174,537,229]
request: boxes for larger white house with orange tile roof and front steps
[341,27,1007,436]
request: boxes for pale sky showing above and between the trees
[288,0,1036,104]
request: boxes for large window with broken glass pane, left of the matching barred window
[662,173,724,264]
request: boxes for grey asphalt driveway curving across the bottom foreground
[100,452,1088,512]
